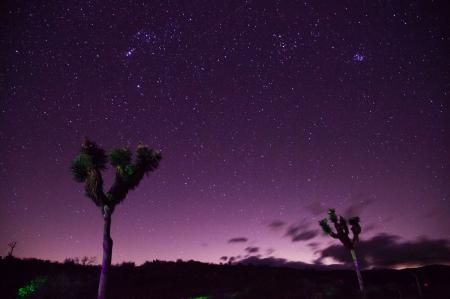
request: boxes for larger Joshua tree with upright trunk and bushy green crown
[71,138,161,299]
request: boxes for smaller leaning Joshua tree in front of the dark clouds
[319,209,364,296]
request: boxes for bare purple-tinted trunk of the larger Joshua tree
[97,205,112,299]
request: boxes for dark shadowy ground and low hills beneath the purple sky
[0,258,450,299]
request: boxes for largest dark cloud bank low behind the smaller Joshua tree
[315,234,450,268]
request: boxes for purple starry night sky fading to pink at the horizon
[0,0,450,264]
